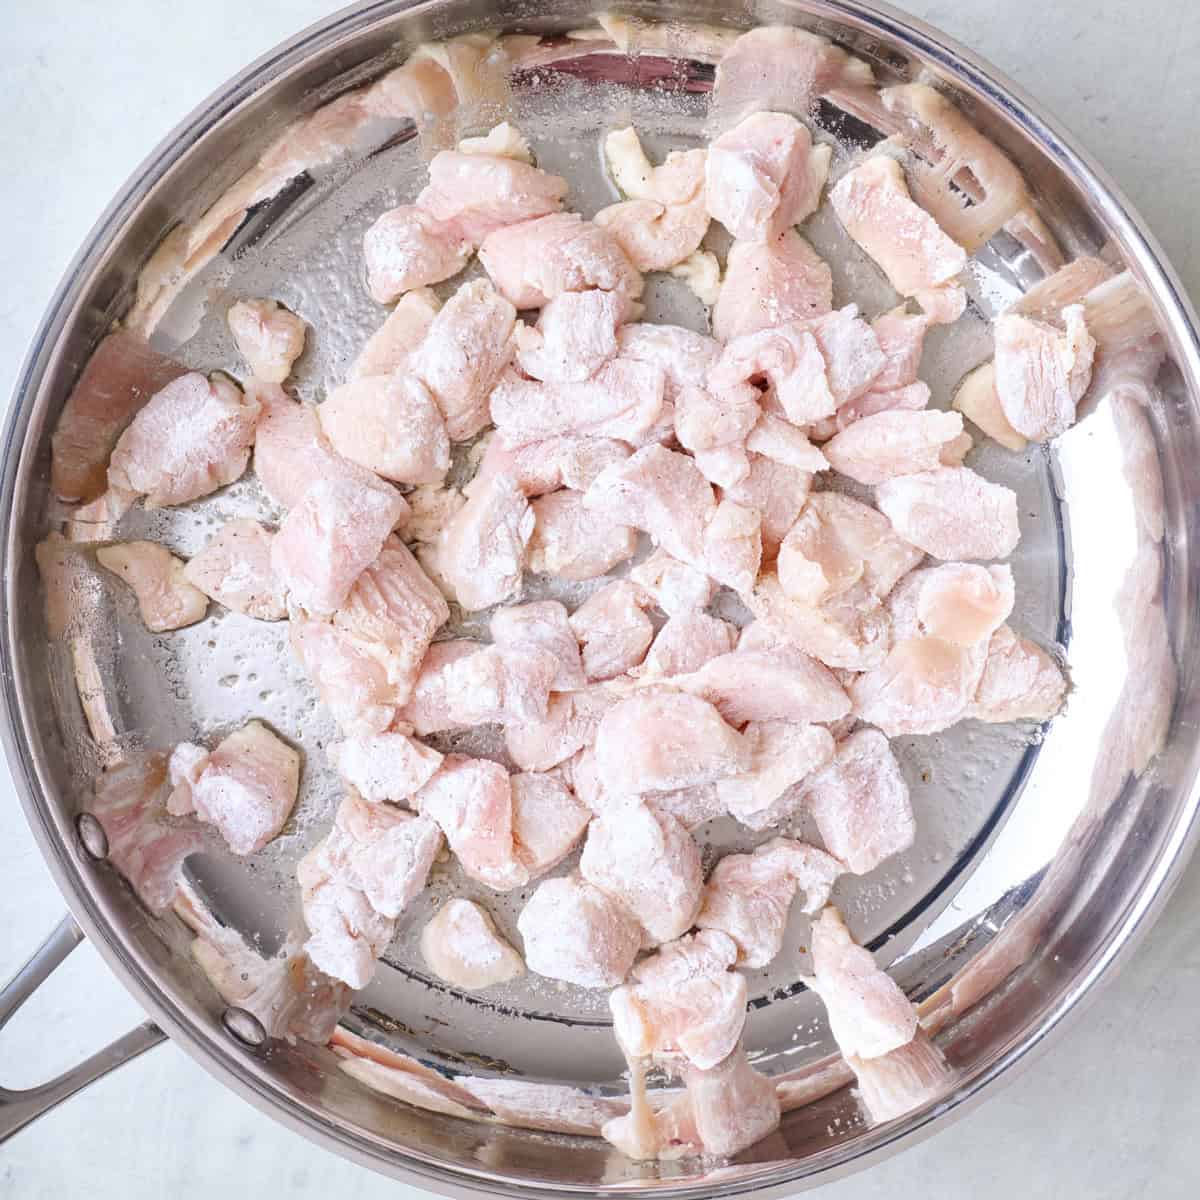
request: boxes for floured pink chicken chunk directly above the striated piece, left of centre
[271,464,408,614]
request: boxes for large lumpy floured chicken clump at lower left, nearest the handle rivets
[296,794,442,988]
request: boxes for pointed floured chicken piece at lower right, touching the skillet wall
[812,905,918,1058]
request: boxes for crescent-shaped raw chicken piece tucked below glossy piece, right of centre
[745,571,892,671]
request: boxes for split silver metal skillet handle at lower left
[0,916,167,1142]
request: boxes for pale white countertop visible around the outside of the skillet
[0,0,1200,1200]
